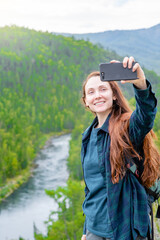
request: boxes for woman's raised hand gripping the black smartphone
[111,57,147,89]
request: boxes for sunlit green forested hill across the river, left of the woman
[0,26,118,200]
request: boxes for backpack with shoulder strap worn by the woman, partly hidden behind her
[127,164,160,240]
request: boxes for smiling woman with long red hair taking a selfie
[81,57,160,240]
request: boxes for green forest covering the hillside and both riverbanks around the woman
[0,26,160,240]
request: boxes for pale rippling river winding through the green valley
[0,134,70,240]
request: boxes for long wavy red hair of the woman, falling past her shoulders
[82,71,160,187]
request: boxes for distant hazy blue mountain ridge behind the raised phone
[56,24,160,74]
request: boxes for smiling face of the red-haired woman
[85,76,115,115]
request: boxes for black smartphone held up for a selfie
[99,62,138,81]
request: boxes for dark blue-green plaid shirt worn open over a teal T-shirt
[81,81,157,240]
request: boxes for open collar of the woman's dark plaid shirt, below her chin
[82,113,111,141]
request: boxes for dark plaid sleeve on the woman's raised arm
[129,81,157,148]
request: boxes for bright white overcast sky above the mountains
[0,0,160,33]
